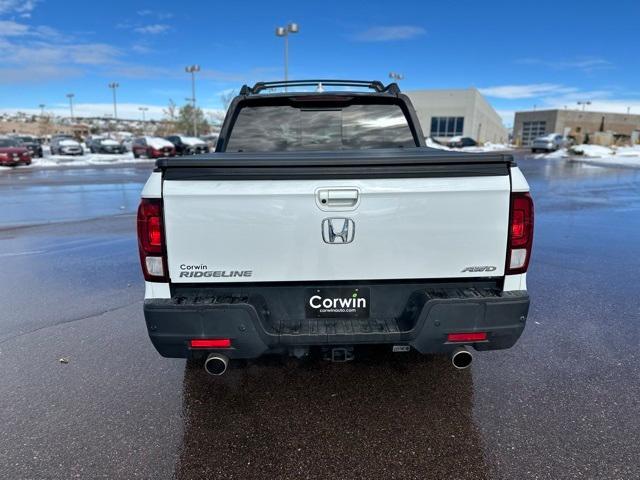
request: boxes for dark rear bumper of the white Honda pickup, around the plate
[144,284,529,359]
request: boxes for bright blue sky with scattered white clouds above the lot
[0,0,640,125]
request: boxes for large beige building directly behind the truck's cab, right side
[406,88,508,143]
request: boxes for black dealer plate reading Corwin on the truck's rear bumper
[305,287,371,318]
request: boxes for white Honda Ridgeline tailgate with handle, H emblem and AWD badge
[163,152,510,283]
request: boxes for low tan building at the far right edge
[513,110,640,146]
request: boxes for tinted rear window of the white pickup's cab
[226,104,416,152]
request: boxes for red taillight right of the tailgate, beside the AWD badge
[506,193,533,275]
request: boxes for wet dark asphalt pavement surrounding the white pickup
[0,158,640,479]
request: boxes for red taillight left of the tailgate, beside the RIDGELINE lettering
[138,198,169,282]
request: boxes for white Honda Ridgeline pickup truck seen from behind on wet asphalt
[138,80,533,374]
